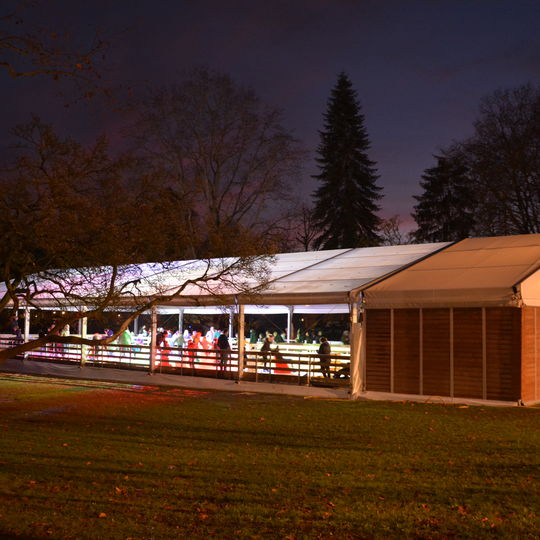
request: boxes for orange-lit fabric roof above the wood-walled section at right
[364,234,540,308]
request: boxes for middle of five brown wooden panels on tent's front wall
[422,308,450,396]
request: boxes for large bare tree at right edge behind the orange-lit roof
[462,84,540,235]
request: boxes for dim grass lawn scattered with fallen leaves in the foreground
[0,374,540,540]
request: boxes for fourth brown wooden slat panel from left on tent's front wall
[454,308,483,399]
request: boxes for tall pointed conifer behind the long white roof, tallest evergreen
[313,73,382,249]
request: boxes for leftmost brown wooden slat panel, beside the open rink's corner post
[366,309,391,392]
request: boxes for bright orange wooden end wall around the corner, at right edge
[521,307,540,402]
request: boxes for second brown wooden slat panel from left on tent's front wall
[394,309,420,394]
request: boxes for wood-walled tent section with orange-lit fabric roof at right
[362,234,540,403]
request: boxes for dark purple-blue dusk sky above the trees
[0,0,540,228]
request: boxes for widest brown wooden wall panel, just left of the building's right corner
[486,307,521,401]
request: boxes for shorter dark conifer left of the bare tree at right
[412,150,475,242]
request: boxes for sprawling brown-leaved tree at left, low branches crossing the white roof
[0,118,267,360]
